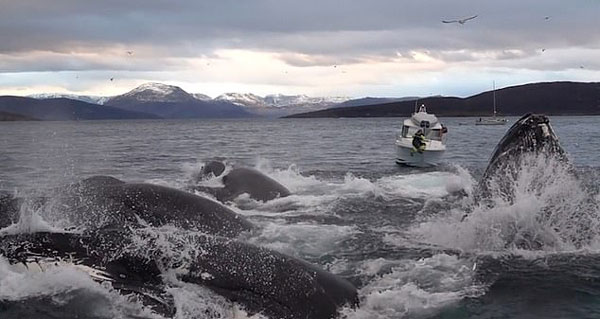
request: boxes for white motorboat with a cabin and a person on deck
[396,105,448,167]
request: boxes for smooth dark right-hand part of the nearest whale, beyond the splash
[177,232,358,319]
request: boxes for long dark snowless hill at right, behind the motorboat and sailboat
[287,82,600,118]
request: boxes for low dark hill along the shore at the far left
[0,96,159,121]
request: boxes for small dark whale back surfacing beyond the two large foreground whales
[193,161,291,202]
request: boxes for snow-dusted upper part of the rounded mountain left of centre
[109,82,196,103]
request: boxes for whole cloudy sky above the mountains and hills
[0,0,600,97]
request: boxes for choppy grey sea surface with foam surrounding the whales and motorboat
[0,117,600,318]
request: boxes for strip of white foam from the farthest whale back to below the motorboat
[226,161,474,215]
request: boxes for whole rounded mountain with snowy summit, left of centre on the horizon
[104,83,255,119]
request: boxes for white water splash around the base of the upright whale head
[411,154,600,251]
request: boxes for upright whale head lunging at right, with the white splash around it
[463,114,598,249]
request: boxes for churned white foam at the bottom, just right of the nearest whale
[342,254,484,319]
